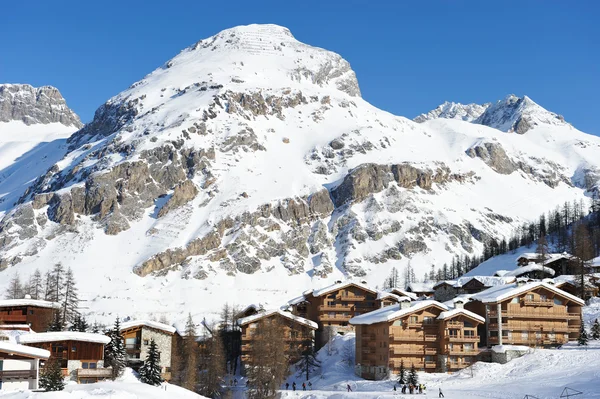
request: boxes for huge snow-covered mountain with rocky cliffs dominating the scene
[0,25,600,320]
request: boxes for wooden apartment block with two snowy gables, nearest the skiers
[350,298,485,380]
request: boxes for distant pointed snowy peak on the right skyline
[473,94,567,134]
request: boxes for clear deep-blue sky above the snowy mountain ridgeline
[0,0,600,134]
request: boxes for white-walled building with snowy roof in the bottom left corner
[0,342,50,391]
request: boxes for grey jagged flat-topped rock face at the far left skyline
[0,84,83,128]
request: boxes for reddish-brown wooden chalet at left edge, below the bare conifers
[0,297,60,332]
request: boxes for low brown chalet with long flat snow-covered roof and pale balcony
[17,331,112,384]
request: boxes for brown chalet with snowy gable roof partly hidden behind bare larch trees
[238,309,317,365]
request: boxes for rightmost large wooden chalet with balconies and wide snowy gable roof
[465,280,585,346]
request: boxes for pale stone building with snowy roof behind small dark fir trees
[121,320,176,381]
